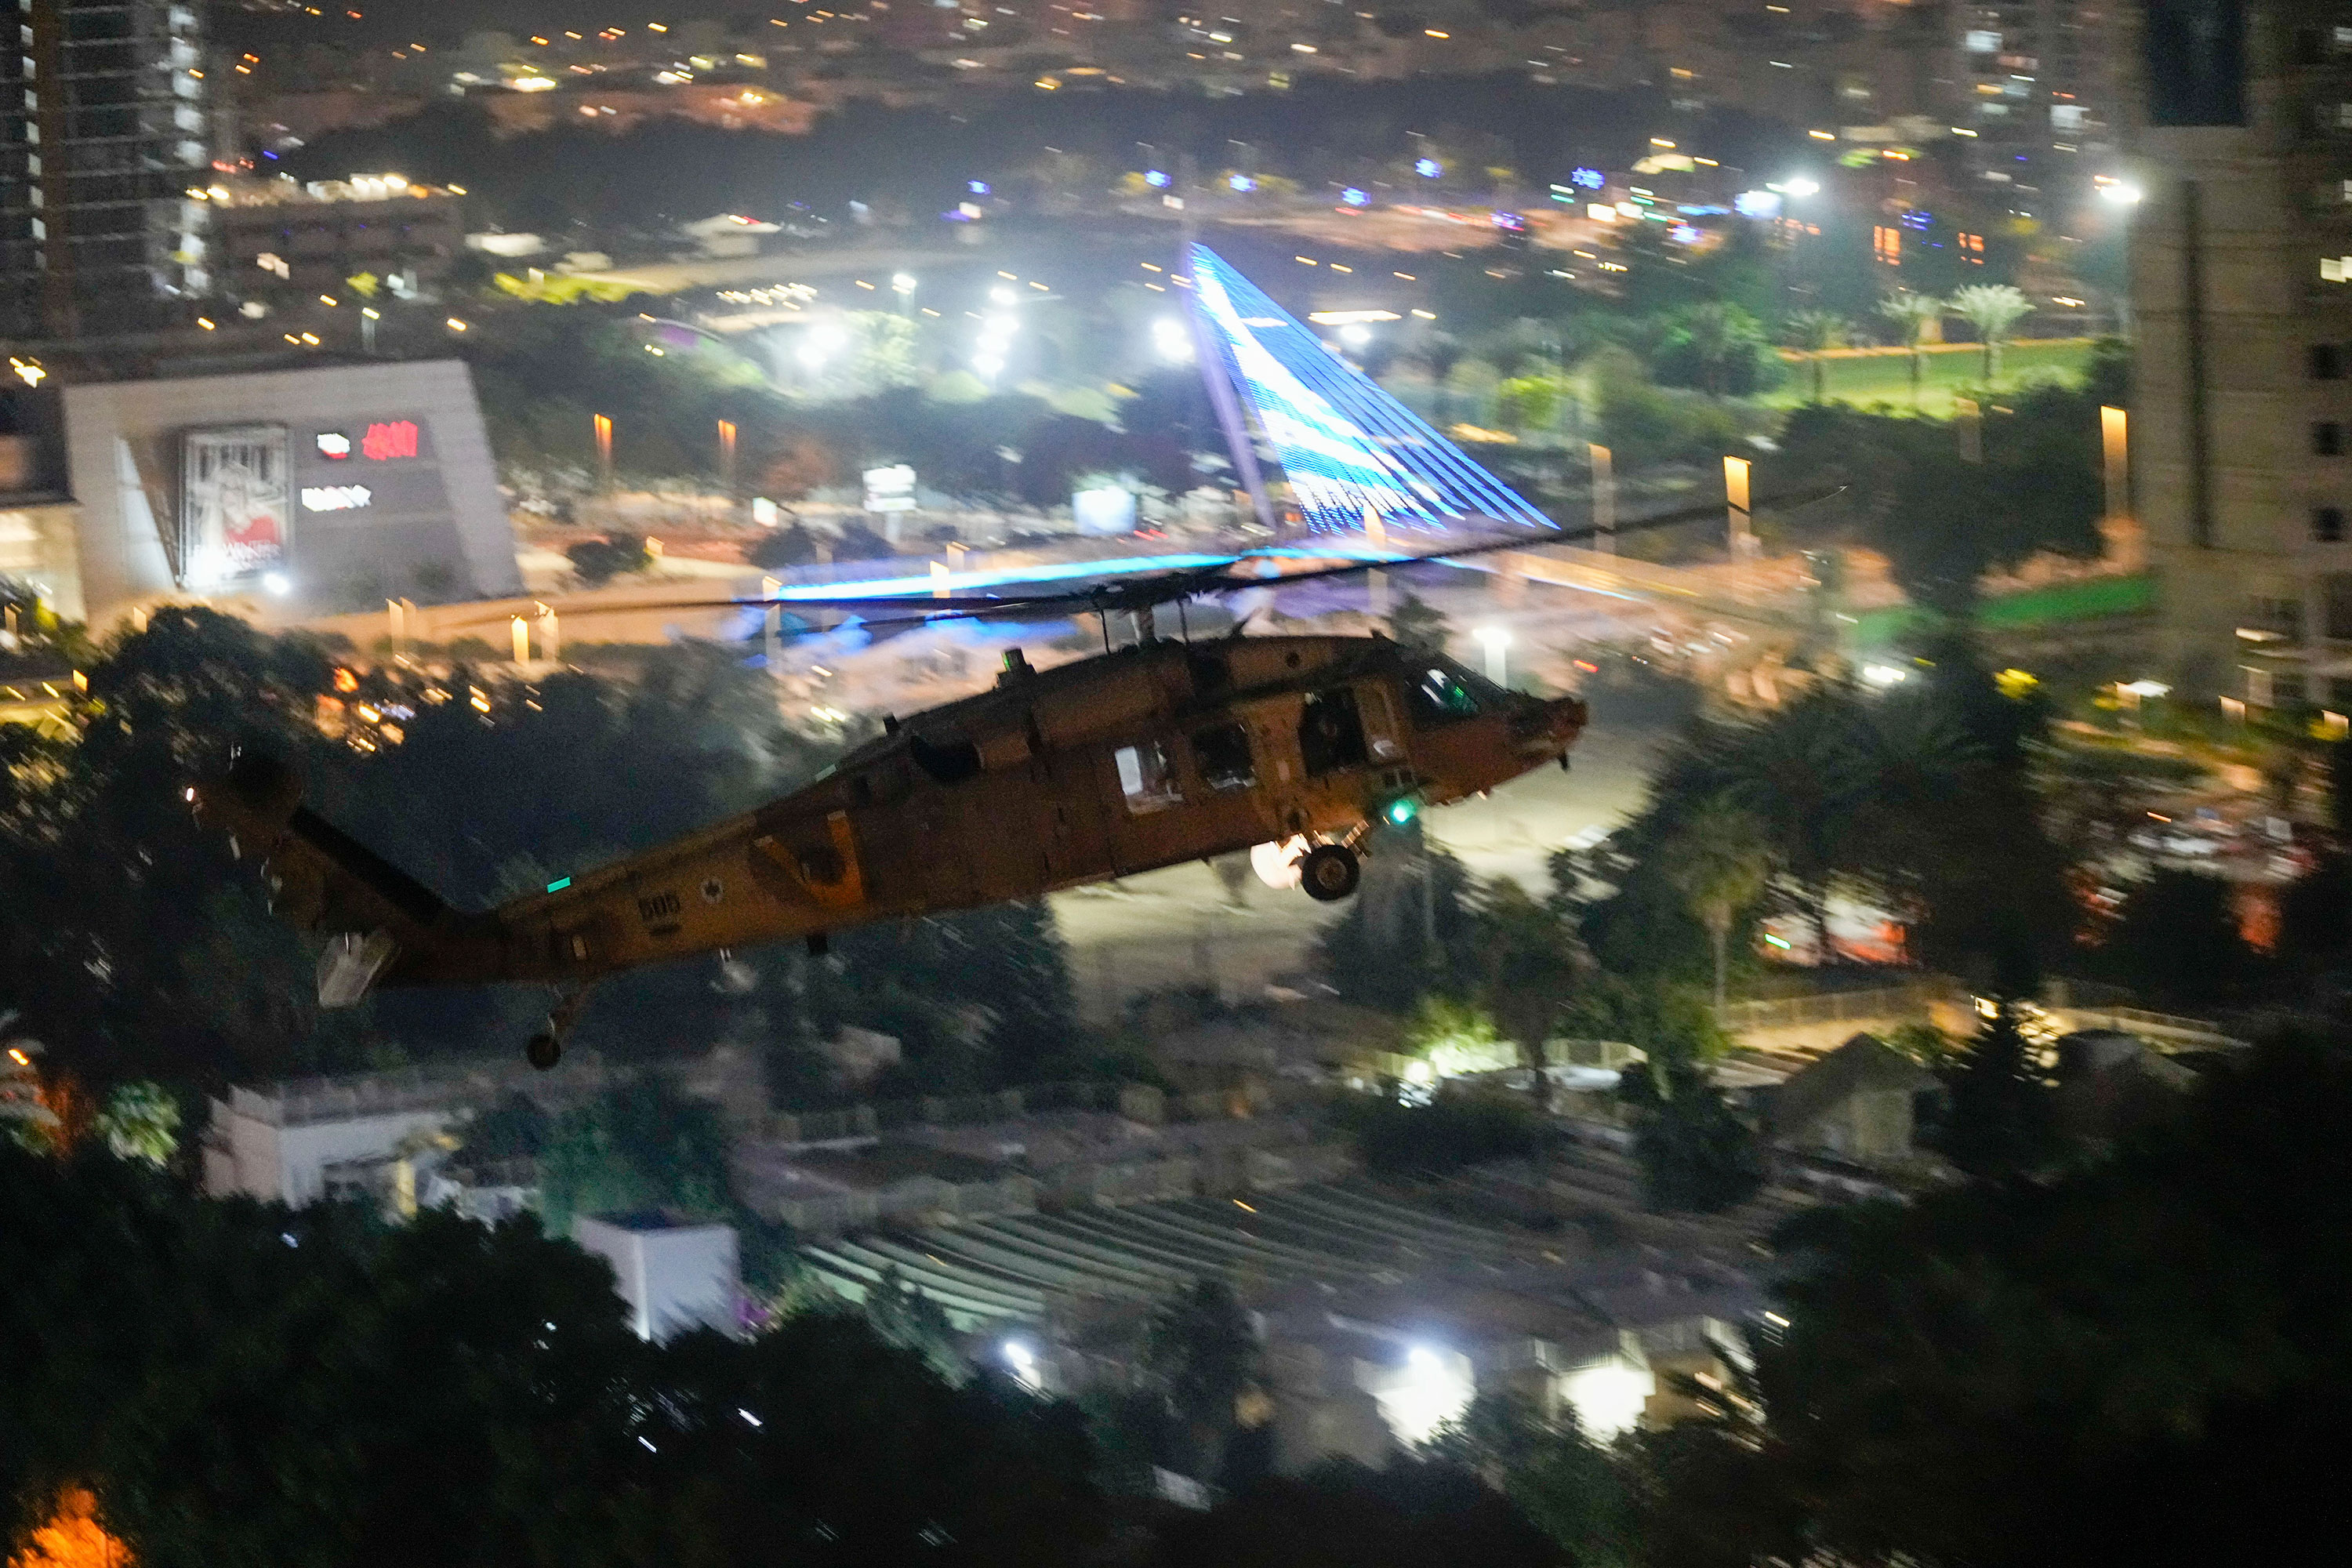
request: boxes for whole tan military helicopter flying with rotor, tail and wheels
[186,491,1816,1069]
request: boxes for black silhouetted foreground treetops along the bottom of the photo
[18,1044,2352,1568]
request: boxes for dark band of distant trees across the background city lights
[285,73,1797,233]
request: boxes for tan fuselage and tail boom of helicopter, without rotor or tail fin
[280,637,1585,985]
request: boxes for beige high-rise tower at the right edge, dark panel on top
[2131,0,2352,706]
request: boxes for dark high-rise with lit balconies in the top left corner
[0,0,212,339]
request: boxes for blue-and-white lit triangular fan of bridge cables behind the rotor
[1188,245,1557,532]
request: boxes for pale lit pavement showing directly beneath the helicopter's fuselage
[1054,729,1668,1022]
